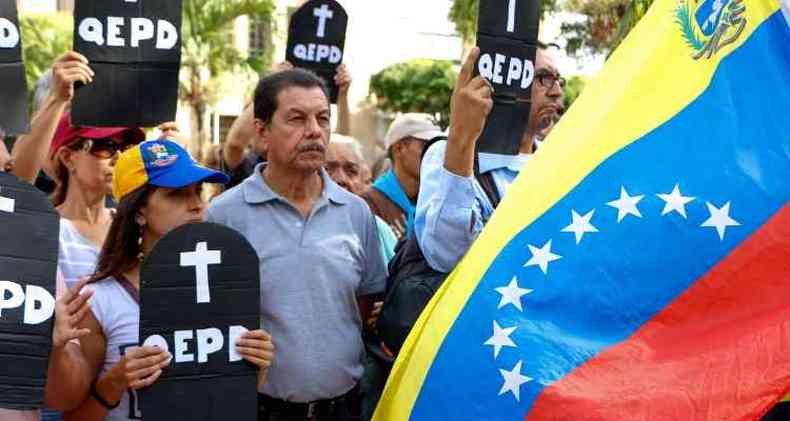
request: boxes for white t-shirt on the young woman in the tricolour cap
[88,278,142,421]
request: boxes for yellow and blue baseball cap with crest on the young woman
[112,140,230,201]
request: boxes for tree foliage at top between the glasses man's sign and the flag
[562,0,653,55]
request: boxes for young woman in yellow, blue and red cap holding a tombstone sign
[66,140,274,421]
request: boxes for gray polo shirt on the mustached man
[208,164,387,402]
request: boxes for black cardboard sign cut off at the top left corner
[0,0,30,136]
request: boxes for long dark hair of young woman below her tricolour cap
[90,185,156,282]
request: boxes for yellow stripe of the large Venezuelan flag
[374,0,779,421]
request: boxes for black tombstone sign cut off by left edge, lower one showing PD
[0,172,60,409]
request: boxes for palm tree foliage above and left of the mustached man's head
[179,0,274,152]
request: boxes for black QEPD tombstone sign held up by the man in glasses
[475,0,540,155]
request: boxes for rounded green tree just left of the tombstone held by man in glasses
[370,59,456,128]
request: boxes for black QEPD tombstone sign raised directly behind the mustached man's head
[285,0,348,104]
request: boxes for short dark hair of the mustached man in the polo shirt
[255,69,329,123]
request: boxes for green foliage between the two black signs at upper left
[19,13,74,97]
